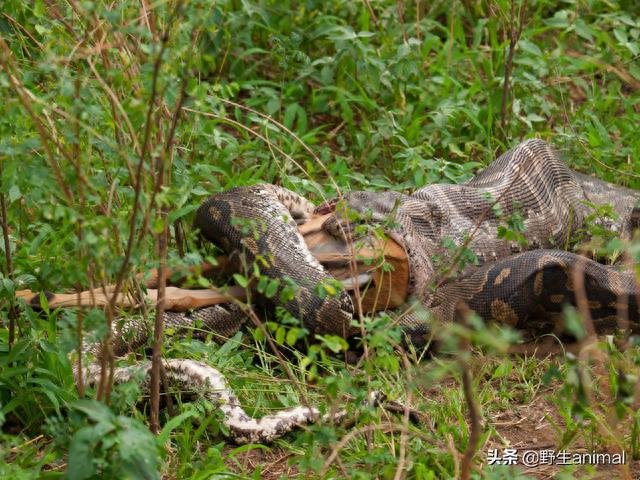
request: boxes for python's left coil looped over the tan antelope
[196,185,353,336]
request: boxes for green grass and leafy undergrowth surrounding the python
[0,0,640,479]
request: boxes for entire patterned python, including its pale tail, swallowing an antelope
[89,139,640,443]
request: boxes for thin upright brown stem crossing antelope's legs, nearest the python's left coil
[151,78,187,434]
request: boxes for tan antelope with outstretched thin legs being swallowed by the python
[16,214,409,312]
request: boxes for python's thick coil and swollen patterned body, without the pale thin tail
[196,139,640,336]
